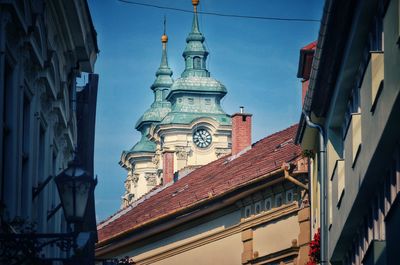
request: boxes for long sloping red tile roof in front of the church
[98,124,301,243]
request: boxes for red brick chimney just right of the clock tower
[231,107,253,155]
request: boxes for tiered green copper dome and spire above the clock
[160,4,231,125]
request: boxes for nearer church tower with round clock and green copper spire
[151,0,232,184]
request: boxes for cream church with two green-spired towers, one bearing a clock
[120,1,231,207]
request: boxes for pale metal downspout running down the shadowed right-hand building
[303,110,329,265]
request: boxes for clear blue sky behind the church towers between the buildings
[88,0,324,221]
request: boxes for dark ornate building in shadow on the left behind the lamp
[0,0,98,264]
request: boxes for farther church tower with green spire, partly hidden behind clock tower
[120,24,173,206]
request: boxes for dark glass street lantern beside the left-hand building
[54,160,97,223]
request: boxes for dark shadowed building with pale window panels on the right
[297,0,400,265]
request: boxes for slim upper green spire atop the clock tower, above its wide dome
[182,0,210,77]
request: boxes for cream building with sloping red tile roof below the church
[96,122,310,265]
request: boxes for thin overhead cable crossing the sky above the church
[117,0,320,22]
